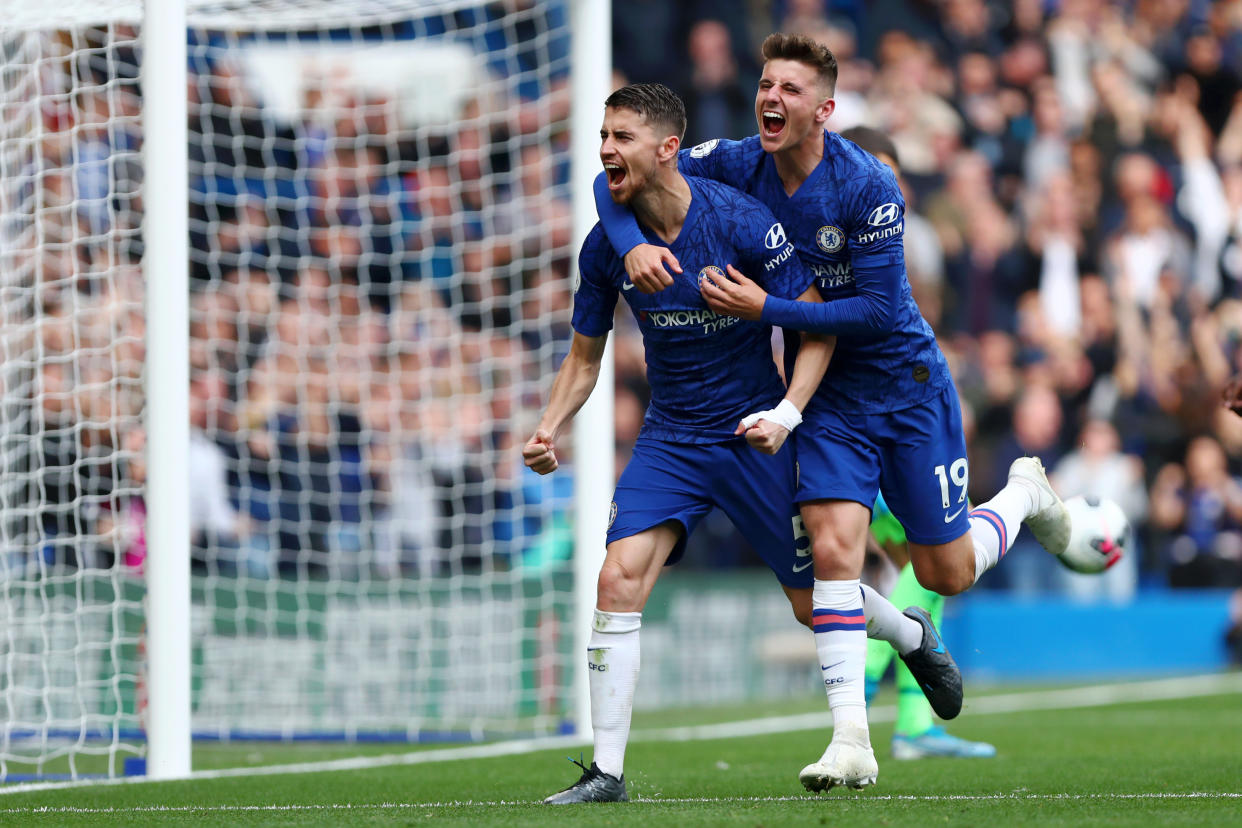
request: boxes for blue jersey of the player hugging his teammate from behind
[679,133,951,413]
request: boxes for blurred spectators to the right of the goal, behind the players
[615,0,1242,615]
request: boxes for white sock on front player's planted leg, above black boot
[586,610,642,778]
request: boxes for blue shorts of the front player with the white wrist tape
[607,437,815,588]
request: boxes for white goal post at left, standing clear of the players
[139,0,191,780]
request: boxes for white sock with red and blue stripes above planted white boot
[811,578,867,737]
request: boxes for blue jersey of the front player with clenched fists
[573,176,811,443]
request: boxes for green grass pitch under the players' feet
[0,680,1242,828]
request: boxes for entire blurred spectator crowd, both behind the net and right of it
[7,0,1242,625]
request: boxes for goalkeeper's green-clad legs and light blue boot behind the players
[866,495,996,758]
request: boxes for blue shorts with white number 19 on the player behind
[792,382,970,545]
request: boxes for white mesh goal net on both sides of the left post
[0,0,586,781]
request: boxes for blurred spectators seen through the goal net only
[0,2,571,578]
